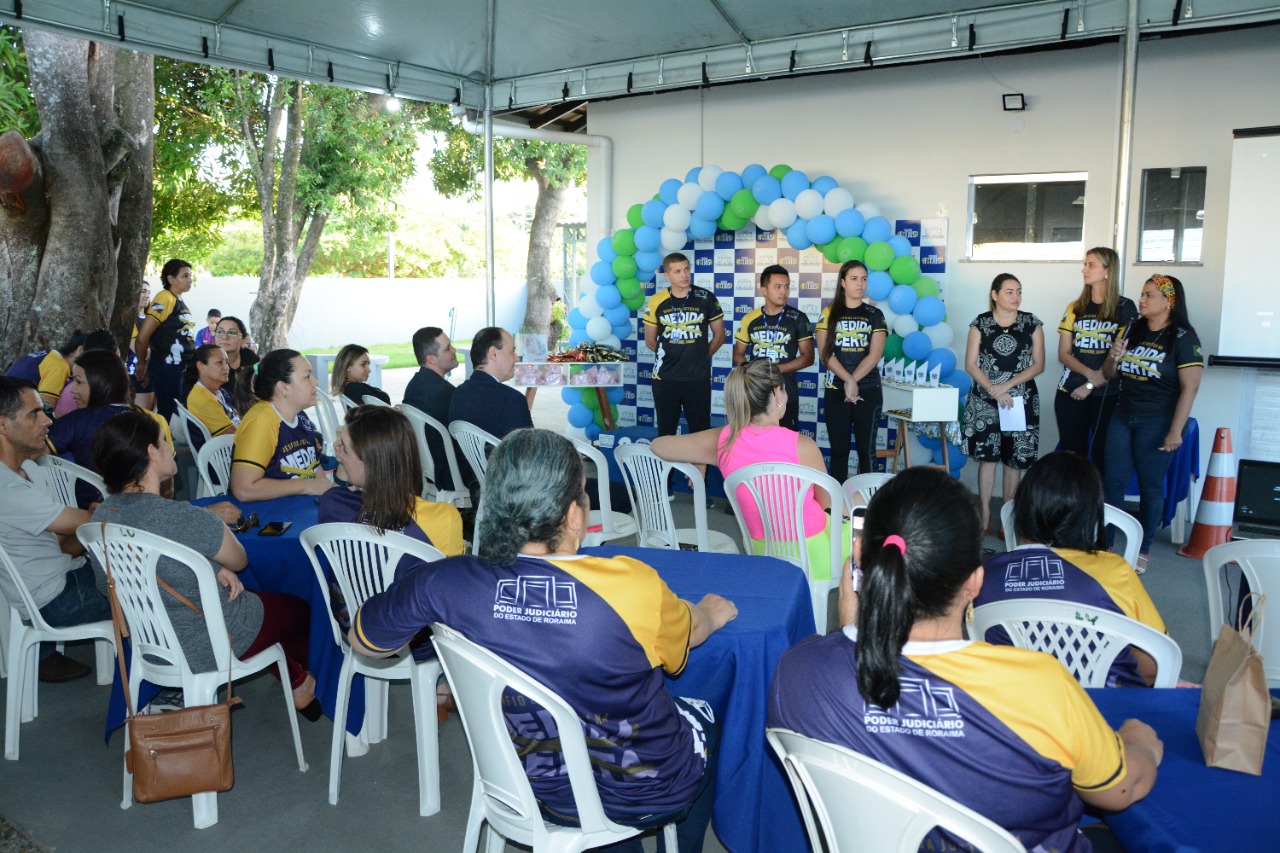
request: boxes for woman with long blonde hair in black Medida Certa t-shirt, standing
[1053,246,1138,471]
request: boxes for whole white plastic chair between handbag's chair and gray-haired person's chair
[298,524,444,817]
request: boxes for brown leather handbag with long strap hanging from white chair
[102,525,239,803]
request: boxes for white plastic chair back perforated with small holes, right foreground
[969,598,1183,688]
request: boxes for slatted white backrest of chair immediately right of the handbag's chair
[298,523,444,648]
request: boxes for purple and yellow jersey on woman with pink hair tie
[768,629,1125,853]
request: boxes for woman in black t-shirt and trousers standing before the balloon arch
[814,261,888,483]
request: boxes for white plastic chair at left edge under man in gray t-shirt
[0,548,115,761]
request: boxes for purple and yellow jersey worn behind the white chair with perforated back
[974,546,1167,686]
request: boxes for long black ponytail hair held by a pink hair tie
[856,466,982,708]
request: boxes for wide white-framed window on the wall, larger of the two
[966,172,1089,260]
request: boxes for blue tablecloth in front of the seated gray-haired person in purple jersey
[584,546,814,853]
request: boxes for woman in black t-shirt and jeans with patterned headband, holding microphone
[1105,275,1204,574]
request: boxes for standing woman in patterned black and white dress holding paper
[963,273,1044,533]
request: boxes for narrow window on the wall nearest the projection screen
[1138,167,1207,264]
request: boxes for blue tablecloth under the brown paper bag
[1089,688,1280,853]
